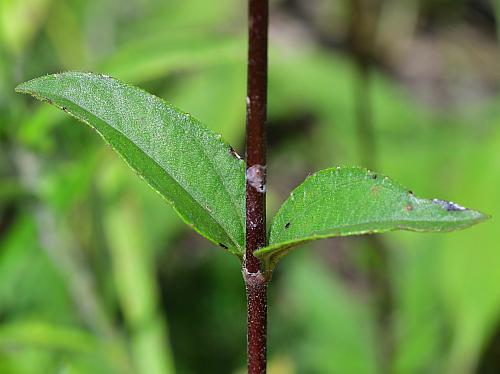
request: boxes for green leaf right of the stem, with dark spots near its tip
[255,167,488,269]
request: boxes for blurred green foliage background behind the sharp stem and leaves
[0,0,500,374]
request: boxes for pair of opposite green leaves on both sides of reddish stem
[16,72,488,271]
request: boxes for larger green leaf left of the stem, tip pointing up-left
[16,72,245,255]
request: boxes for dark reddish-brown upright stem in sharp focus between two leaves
[243,0,269,374]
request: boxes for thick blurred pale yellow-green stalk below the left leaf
[104,198,175,374]
